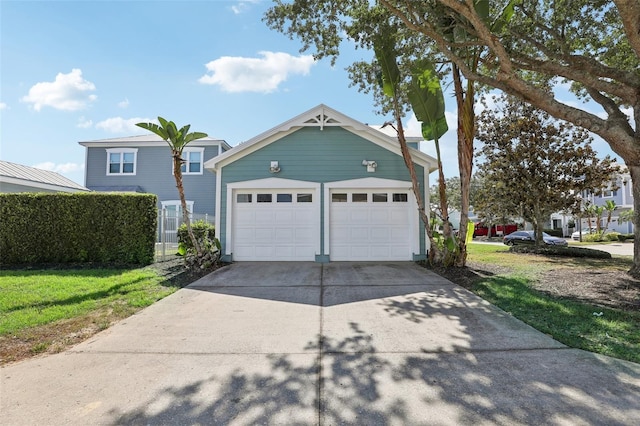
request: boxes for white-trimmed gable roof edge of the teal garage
[204,104,437,172]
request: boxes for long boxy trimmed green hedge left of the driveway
[0,192,158,265]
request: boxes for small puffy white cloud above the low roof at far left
[21,68,97,111]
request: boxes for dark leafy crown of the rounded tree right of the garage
[477,95,619,245]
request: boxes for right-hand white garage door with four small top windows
[329,189,413,261]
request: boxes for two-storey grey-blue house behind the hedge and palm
[80,133,231,217]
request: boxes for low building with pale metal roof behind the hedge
[0,161,89,192]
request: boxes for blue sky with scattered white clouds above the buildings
[0,0,620,184]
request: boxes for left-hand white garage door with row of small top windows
[232,189,320,261]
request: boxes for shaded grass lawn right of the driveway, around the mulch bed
[468,244,640,362]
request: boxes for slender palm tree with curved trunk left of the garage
[136,117,208,260]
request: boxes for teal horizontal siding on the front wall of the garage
[218,127,425,254]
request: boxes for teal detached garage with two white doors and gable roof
[205,105,437,262]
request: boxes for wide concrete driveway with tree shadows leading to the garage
[0,263,640,425]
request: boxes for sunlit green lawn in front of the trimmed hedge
[0,268,177,344]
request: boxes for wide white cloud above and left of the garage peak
[198,51,315,93]
